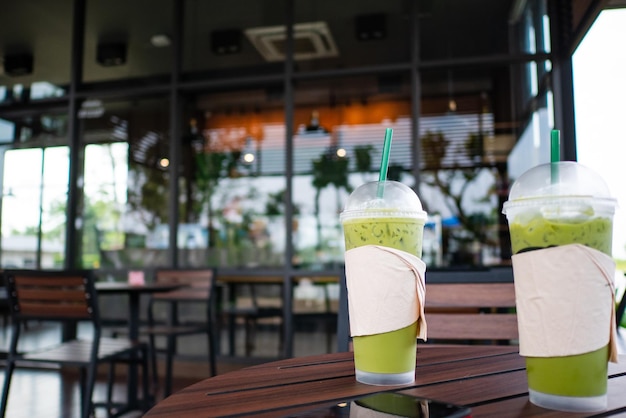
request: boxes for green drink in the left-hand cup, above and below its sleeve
[343,217,424,373]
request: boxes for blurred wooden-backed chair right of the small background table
[140,268,217,397]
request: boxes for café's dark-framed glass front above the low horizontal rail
[0,0,620,275]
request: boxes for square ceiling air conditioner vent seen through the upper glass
[244,22,339,61]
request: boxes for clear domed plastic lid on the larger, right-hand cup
[502,161,616,214]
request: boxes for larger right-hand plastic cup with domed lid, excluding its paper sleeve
[503,162,616,411]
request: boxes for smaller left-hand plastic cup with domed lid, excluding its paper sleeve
[341,181,426,385]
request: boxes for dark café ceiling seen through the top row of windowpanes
[0,0,621,104]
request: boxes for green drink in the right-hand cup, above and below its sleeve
[509,216,613,397]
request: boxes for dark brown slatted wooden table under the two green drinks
[145,345,626,418]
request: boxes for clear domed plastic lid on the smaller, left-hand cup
[340,181,427,221]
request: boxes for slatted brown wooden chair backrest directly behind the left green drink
[337,266,518,351]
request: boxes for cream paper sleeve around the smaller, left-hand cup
[345,245,426,340]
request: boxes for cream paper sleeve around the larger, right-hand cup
[512,244,618,362]
